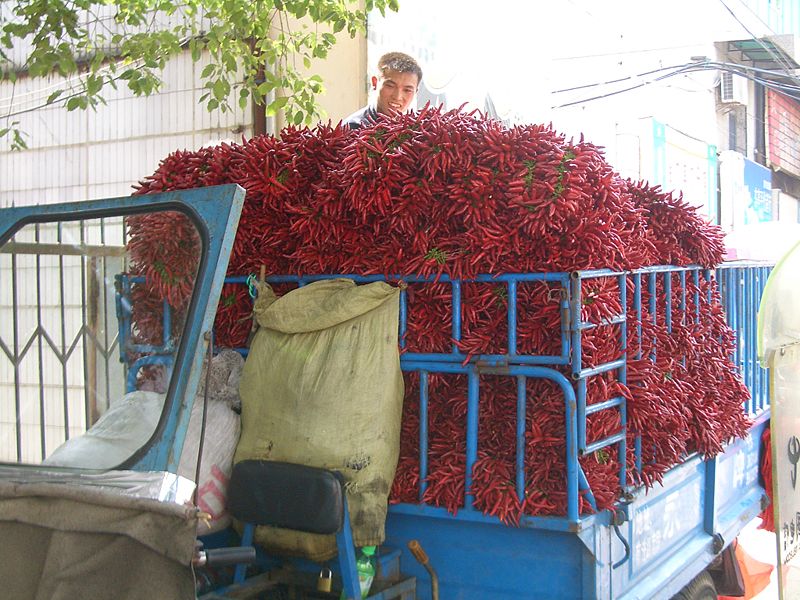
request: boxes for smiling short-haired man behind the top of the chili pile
[342,52,422,129]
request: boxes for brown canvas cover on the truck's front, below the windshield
[0,481,197,600]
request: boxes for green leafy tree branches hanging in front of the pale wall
[0,0,398,144]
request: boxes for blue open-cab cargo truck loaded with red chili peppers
[0,185,770,600]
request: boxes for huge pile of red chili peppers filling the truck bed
[128,108,748,523]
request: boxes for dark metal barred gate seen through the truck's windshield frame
[0,222,124,463]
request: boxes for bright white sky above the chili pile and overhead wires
[370,0,780,121]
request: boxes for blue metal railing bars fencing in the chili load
[118,264,770,522]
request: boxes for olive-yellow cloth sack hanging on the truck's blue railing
[234,279,403,561]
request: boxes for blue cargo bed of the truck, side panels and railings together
[112,264,769,599]
